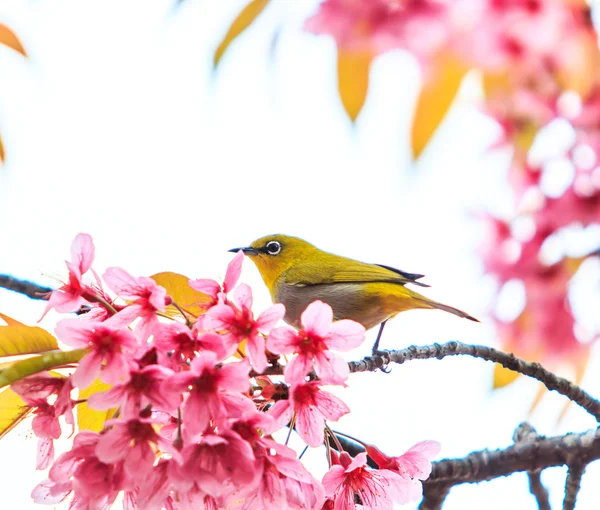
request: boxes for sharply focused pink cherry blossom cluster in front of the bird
[12,234,439,510]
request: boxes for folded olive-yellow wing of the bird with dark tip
[284,256,429,287]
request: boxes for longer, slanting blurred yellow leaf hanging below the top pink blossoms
[411,53,468,159]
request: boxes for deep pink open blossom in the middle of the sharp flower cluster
[163,351,253,435]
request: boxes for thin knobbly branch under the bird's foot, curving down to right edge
[348,341,600,422]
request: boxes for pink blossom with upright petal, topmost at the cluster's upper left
[40,234,105,320]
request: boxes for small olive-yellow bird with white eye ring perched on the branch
[229,234,479,354]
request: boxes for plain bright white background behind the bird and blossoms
[0,0,600,510]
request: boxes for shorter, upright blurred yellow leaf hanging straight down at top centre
[337,48,373,122]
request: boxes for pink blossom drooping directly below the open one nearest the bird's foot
[269,381,350,446]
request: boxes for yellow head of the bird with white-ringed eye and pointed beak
[229,234,317,293]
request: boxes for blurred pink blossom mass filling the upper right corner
[305,0,600,373]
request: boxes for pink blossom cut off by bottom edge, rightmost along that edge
[323,452,410,510]
